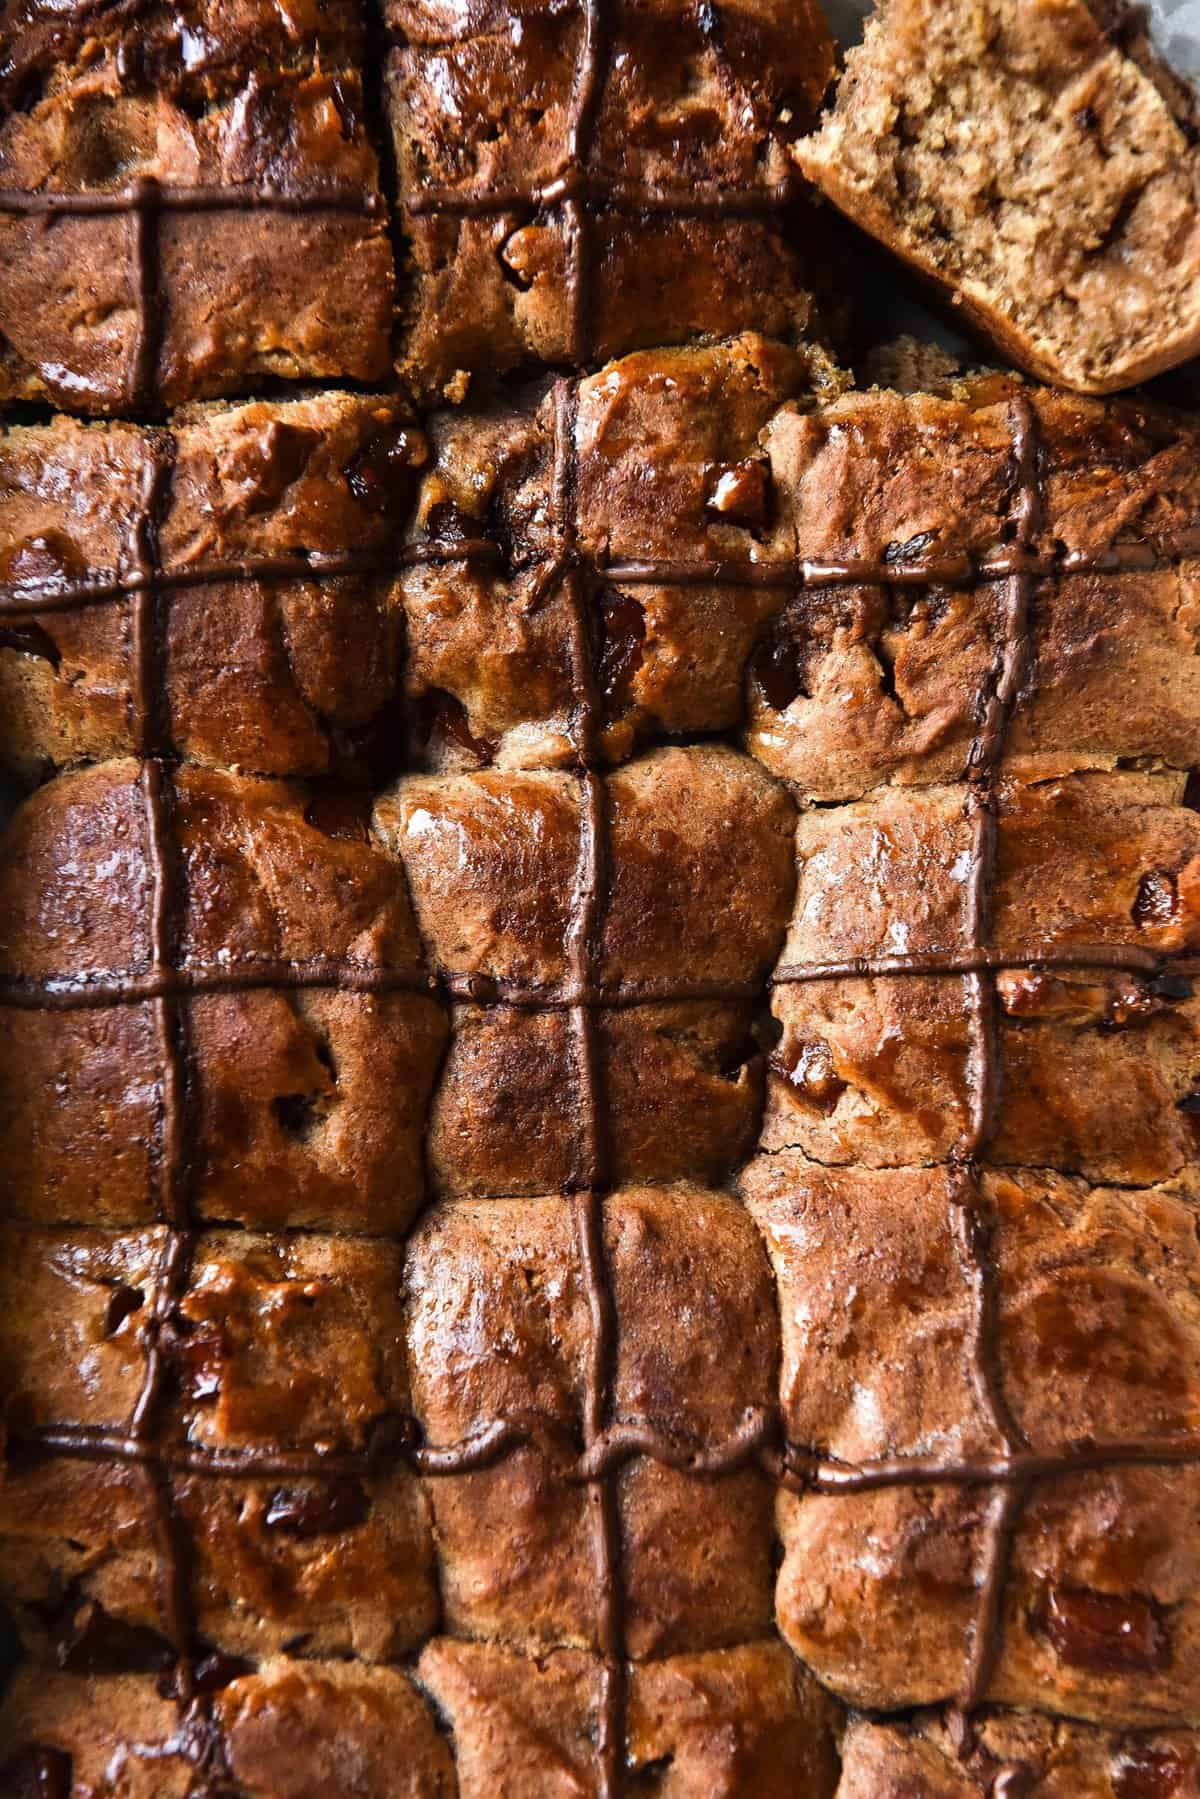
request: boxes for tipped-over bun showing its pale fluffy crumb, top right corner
[795,0,1200,392]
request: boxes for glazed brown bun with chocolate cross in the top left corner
[0,0,394,414]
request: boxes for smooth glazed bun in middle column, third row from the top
[376,747,793,1196]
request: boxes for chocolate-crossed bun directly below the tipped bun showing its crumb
[747,378,1196,802]
